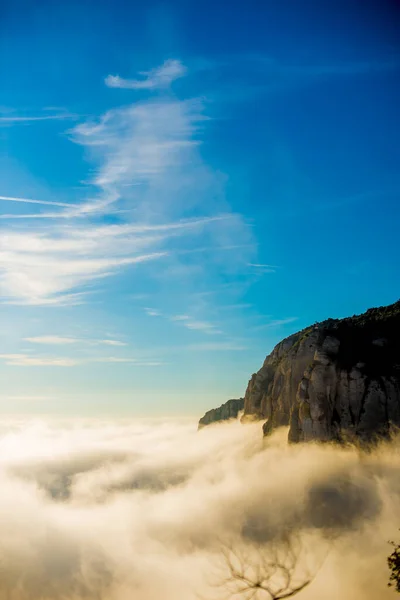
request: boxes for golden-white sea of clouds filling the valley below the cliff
[0,419,400,600]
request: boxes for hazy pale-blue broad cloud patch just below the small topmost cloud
[71,99,204,203]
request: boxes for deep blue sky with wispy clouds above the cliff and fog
[0,0,400,415]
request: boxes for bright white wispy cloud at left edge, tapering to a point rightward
[0,217,233,305]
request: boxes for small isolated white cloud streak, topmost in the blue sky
[105,59,187,90]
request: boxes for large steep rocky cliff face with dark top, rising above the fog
[242,301,400,442]
